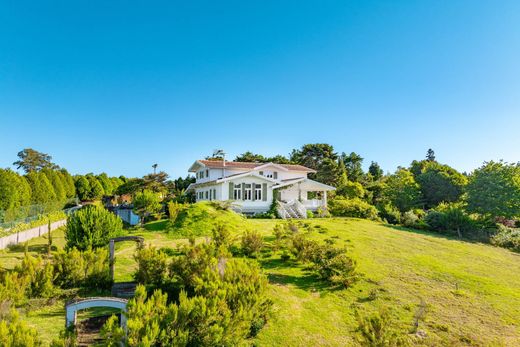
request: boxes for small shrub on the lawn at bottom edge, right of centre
[356,309,409,347]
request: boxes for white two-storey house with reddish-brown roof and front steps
[188,160,335,218]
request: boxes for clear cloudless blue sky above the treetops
[0,0,520,176]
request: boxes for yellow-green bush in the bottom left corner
[0,309,42,347]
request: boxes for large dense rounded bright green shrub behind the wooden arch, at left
[65,205,123,251]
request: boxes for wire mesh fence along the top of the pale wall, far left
[0,198,79,230]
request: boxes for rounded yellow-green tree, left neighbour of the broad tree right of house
[384,168,421,212]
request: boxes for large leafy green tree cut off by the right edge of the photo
[466,161,520,218]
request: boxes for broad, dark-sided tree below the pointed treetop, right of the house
[416,161,468,208]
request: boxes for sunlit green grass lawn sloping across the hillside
[0,218,520,346]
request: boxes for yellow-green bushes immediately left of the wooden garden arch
[53,248,111,289]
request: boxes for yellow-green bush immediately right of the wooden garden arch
[134,246,168,288]
